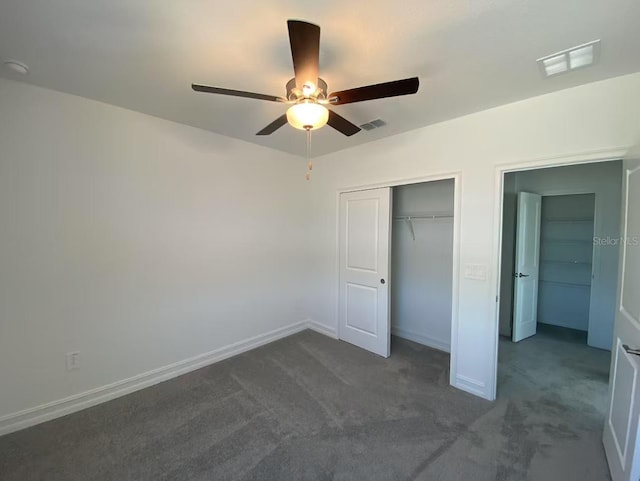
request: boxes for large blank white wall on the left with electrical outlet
[0,80,308,430]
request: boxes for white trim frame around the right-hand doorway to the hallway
[490,148,628,401]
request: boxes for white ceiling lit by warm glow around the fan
[0,0,640,155]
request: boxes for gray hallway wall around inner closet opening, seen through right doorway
[500,161,622,350]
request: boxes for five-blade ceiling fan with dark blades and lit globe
[191,20,420,136]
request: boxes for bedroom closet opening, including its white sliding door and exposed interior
[338,176,459,357]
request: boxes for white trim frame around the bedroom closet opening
[335,171,462,385]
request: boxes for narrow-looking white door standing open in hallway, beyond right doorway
[511,192,542,342]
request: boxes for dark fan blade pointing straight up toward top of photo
[287,20,320,90]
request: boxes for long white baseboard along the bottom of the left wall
[0,320,310,436]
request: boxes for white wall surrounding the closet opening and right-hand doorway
[309,74,640,398]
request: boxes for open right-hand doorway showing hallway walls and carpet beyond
[497,161,622,398]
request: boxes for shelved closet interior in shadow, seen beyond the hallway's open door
[538,194,595,331]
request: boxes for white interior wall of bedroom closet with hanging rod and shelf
[391,179,454,351]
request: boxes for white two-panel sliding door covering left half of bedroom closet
[339,187,391,357]
